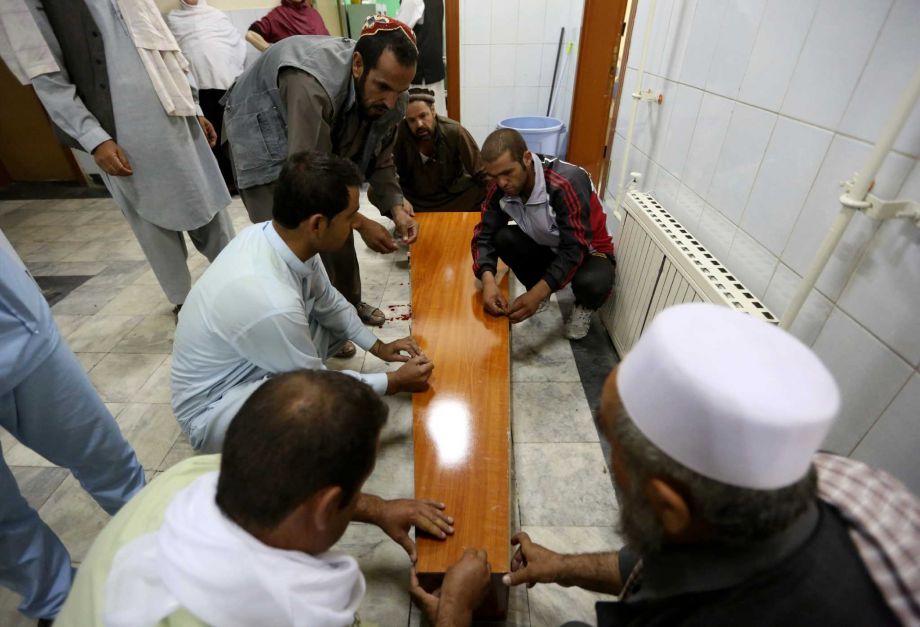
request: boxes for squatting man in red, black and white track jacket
[472,128,615,340]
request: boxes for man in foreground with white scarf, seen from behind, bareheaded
[55,370,489,627]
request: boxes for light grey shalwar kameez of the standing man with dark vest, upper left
[30,0,233,304]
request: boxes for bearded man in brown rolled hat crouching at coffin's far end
[393,87,485,211]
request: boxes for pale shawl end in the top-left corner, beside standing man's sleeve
[0,0,61,85]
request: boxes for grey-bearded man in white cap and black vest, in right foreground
[506,304,920,627]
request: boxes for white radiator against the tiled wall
[601,191,777,356]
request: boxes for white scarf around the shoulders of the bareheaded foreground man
[103,472,365,627]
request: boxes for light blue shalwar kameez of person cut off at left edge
[0,238,144,618]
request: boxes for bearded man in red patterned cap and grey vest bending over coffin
[224,16,418,357]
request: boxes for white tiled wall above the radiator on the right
[607,0,920,493]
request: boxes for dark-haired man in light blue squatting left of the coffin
[172,152,433,453]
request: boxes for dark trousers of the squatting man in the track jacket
[495,225,614,309]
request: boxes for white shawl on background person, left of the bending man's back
[166,0,246,89]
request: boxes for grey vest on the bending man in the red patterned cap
[221,35,406,189]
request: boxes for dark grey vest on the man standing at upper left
[43,0,117,150]
